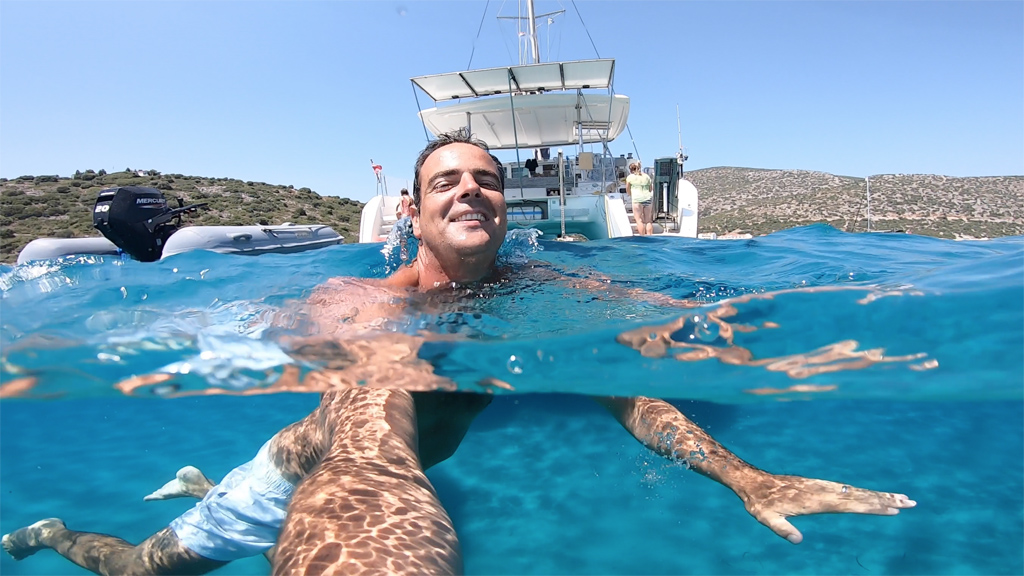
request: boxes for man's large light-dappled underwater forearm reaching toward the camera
[273,388,462,574]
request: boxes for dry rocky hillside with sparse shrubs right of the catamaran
[686,168,1024,238]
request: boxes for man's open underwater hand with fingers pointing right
[736,472,918,544]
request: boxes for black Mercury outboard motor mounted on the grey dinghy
[92,186,206,262]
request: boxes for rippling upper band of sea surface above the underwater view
[0,225,1024,403]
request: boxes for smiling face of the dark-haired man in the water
[413,142,508,257]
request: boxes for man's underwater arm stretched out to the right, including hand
[594,397,916,544]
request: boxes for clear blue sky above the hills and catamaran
[0,0,1024,200]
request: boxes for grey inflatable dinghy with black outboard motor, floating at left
[17,187,344,264]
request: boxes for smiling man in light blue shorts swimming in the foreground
[3,134,914,574]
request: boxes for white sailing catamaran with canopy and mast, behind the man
[359,1,697,242]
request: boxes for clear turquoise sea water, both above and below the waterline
[0,225,1024,574]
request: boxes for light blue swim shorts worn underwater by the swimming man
[171,442,295,562]
